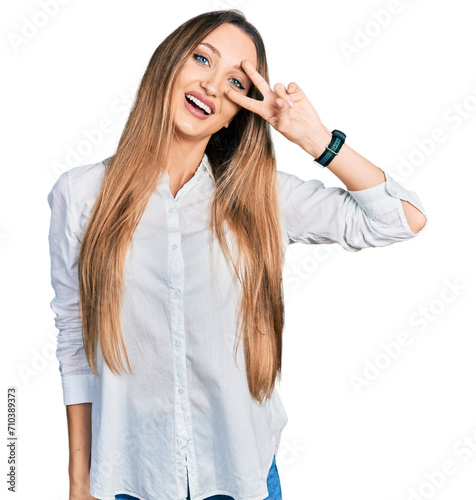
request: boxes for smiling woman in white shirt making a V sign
[48,10,426,500]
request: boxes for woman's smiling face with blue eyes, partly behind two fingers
[172,23,258,144]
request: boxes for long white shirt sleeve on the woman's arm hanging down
[48,171,95,405]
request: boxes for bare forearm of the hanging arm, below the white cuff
[66,403,92,480]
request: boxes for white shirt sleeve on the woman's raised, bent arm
[278,170,428,252]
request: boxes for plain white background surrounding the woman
[0,0,476,500]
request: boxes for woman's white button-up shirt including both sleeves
[48,155,426,500]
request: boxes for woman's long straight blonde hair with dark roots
[78,9,284,403]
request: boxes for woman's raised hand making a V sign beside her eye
[226,60,327,145]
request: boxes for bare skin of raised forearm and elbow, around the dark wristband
[300,127,426,233]
